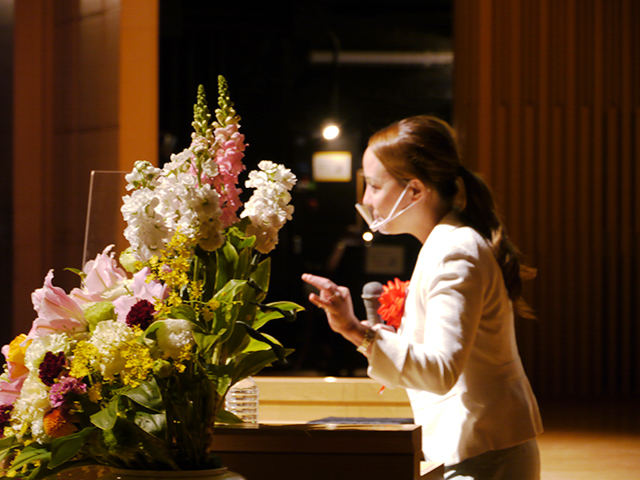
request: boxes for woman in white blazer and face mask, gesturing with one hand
[302,116,542,480]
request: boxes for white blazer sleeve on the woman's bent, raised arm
[368,248,487,395]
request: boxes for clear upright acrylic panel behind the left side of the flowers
[82,170,129,265]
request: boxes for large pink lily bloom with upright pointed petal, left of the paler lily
[28,270,87,338]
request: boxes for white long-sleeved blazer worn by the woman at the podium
[368,214,542,465]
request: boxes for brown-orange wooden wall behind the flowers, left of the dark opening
[12,0,159,336]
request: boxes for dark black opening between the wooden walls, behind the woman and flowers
[160,0,452,375]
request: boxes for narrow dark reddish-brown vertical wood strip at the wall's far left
[12,1,53,336]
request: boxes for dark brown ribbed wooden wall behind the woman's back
[454,0,640,396]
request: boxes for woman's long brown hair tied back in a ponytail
[369,115,535,318]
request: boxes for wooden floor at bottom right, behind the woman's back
[538,401,640,480]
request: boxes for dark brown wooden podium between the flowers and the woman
[212,424,443,480]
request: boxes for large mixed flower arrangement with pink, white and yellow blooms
[0,77,301,479]
